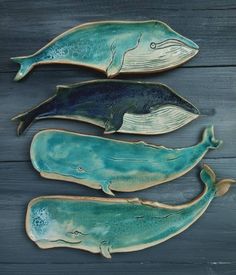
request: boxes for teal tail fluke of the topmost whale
[11,56,34,81]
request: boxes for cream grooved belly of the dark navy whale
[118,105,198,135]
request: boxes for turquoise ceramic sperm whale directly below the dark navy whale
[30,127,221,195]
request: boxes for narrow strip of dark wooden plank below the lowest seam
[2,262,236,275]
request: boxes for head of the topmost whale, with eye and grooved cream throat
[121,21,199,72]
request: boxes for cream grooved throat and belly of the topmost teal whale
[121,40,197,73]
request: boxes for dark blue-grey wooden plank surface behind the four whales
[0,0,236,275]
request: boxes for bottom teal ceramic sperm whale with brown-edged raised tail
[26,165,235,258]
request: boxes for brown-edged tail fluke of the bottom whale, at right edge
[200,164,236,197]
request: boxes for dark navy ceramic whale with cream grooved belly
[13,80,200,135]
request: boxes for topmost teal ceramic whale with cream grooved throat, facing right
[12,20,199,80]
